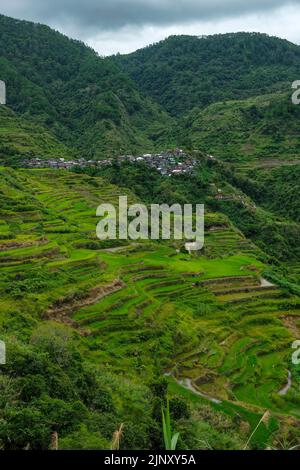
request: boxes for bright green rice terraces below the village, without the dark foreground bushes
[0,168,300,434]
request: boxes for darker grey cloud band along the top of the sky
[0,0,300,37]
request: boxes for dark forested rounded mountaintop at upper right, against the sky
[114,33,300,116]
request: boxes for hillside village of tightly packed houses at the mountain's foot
[26,149,196,176]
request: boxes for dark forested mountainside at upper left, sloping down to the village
[0,16,170,157]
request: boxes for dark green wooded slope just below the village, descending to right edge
[91,157,300,264]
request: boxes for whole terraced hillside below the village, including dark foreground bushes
[0,168,299,449]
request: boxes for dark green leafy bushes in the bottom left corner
[0,324,118,449]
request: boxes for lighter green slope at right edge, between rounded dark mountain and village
[182,93,300,165]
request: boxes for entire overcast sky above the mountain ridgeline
[0,0,300,55]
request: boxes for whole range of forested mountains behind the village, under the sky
[0,16,300,161]
